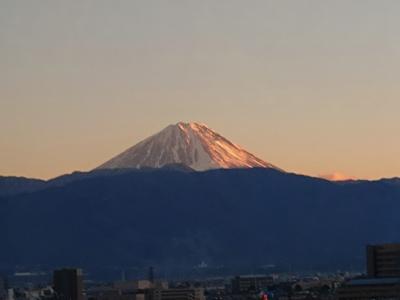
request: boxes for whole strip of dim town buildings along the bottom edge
[0,244,400,300]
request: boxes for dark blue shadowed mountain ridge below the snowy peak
[0,169,400,270]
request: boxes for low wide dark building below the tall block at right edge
[336,278,400,300]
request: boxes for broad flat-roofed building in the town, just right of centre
[231,275,274,294]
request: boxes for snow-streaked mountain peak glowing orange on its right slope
[97,122,279,171]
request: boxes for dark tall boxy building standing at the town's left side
[53,269,83,300]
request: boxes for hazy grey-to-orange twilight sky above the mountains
[0,0,400,178]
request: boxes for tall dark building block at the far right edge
[367,244,400,277]
